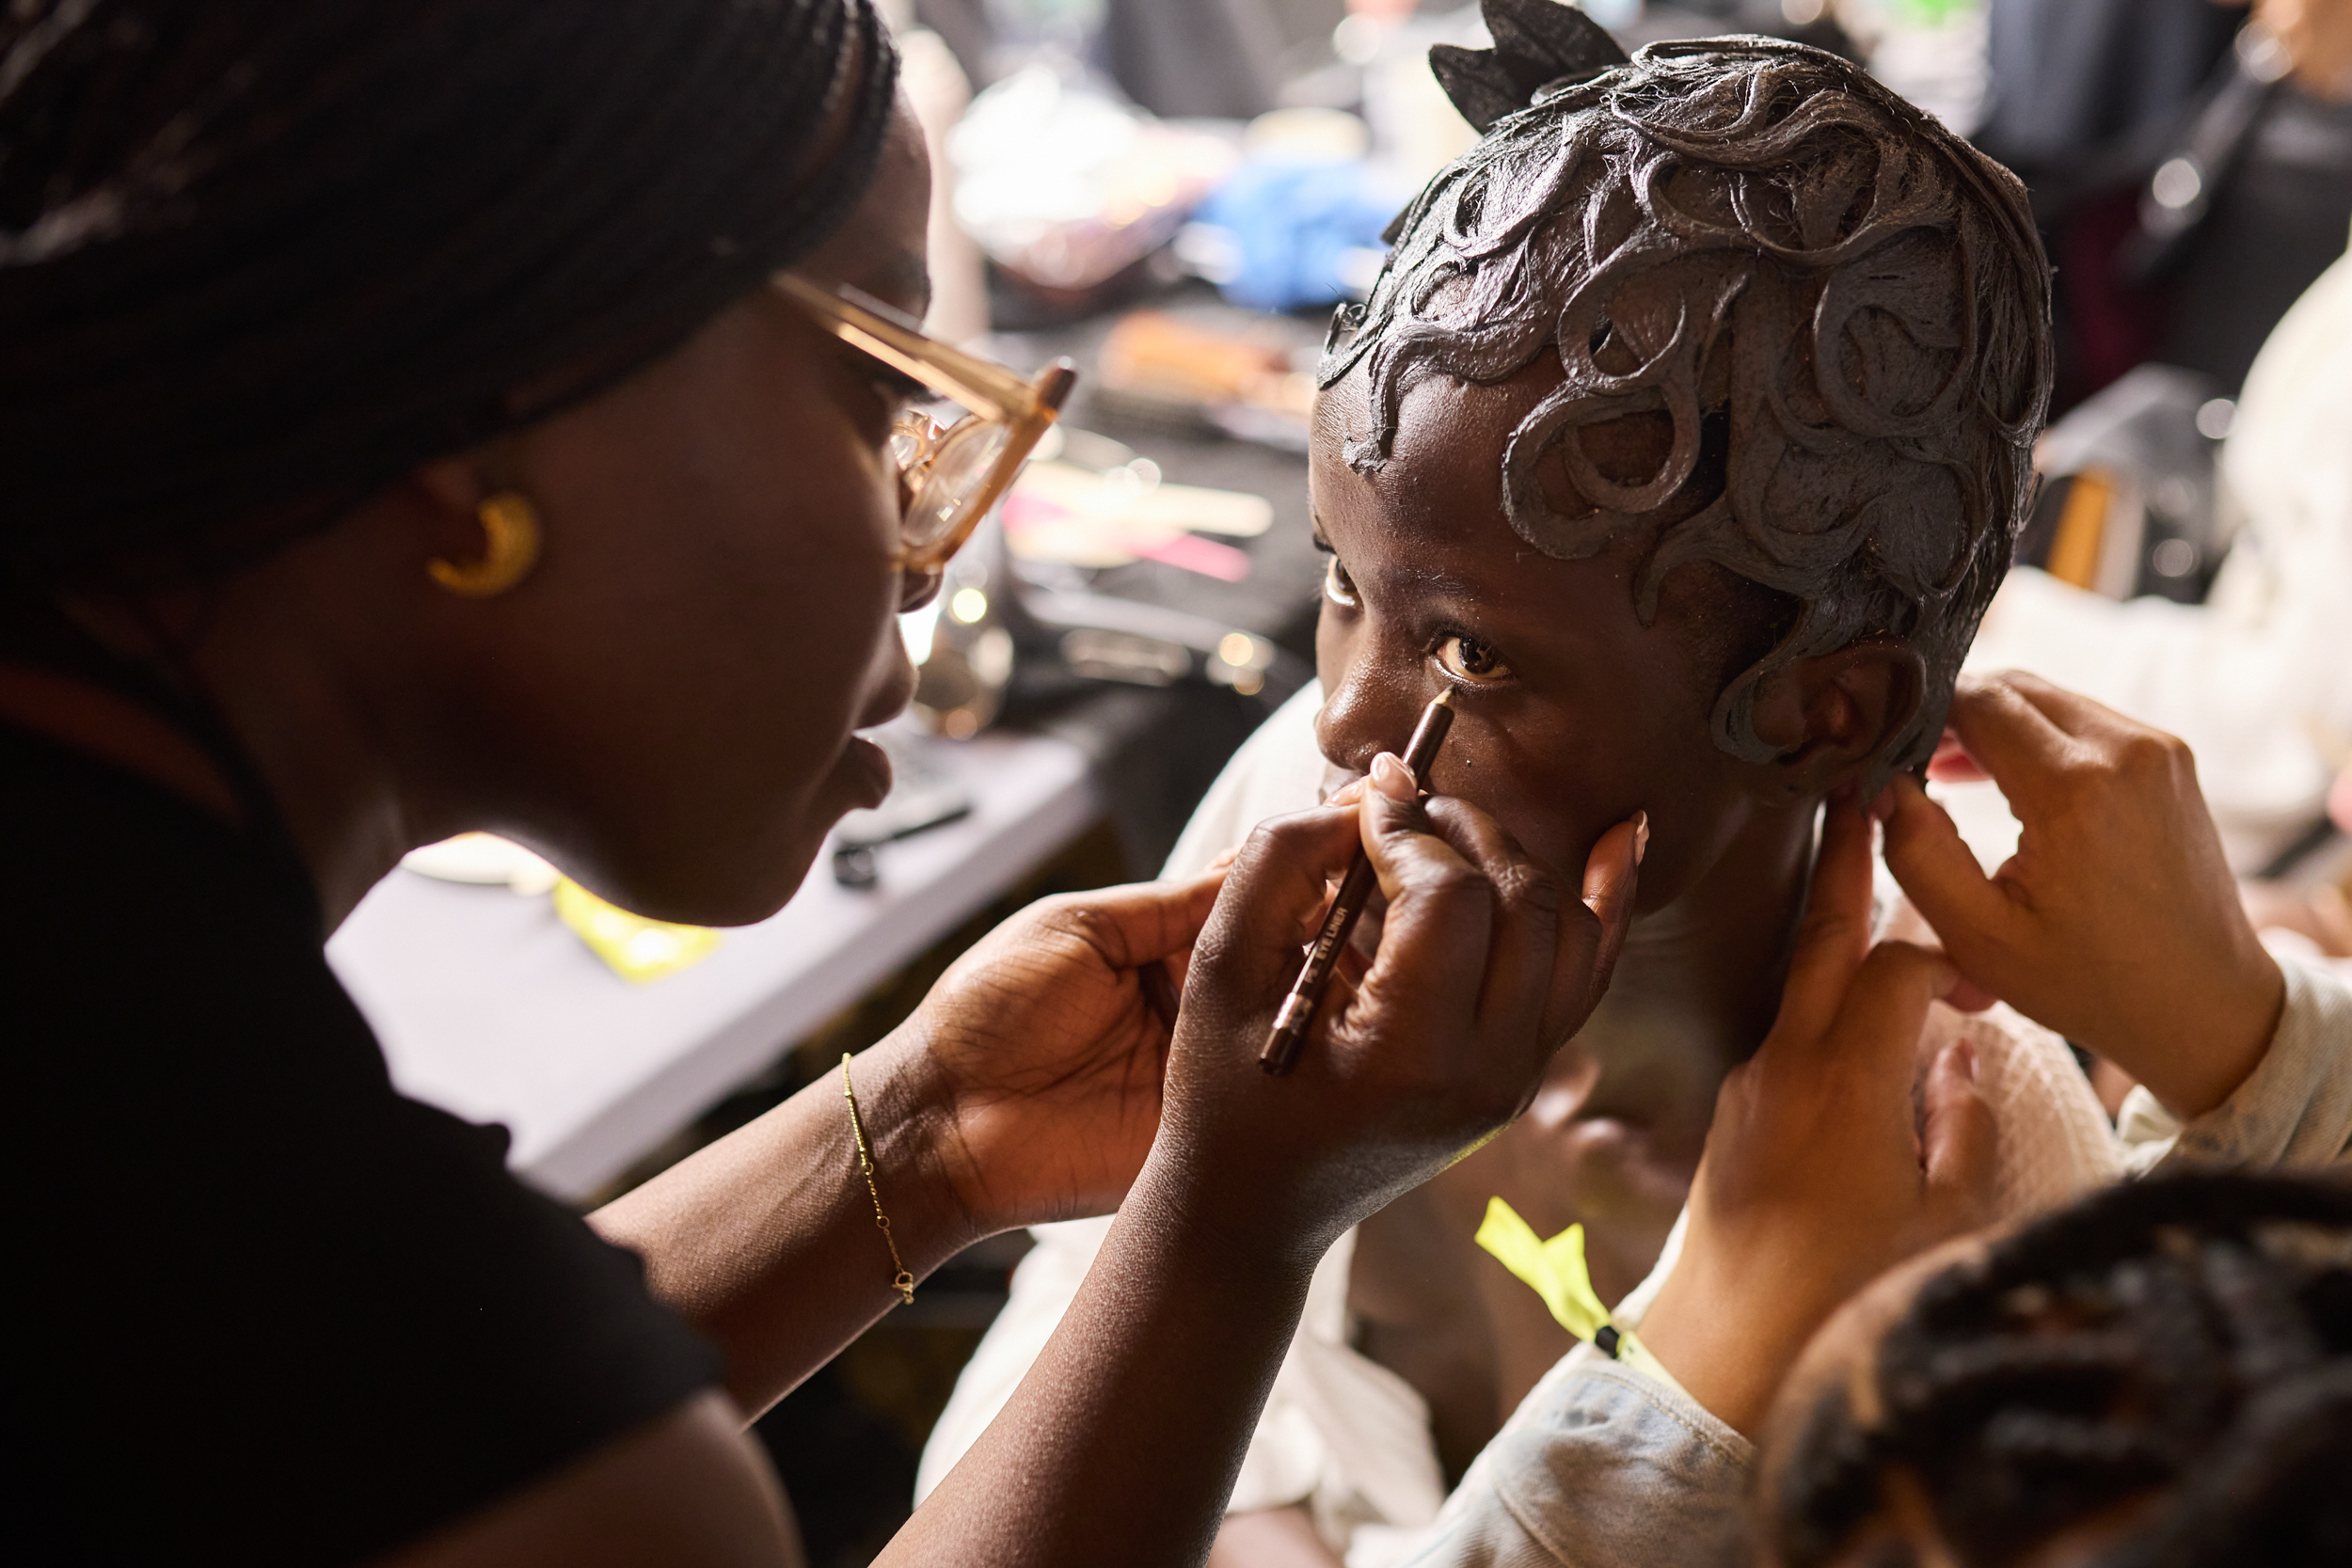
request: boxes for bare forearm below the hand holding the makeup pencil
[880,1182,1315,1568]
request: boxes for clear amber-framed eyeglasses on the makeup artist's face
[771,273,1077,571]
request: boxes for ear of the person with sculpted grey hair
[1755,637,1927,801]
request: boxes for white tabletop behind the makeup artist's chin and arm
[327,736,1101,1199]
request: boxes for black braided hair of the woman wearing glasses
[0,0,897,576]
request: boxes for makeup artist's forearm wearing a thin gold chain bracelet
[591,1032,981,1416]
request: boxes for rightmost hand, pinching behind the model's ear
[1886,674,2286,1117]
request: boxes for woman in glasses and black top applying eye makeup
[0,0,1637,1566]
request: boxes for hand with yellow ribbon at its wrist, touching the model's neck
[1640,801,1994,1434]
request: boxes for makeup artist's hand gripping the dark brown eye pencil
[1129,754,1642,1265]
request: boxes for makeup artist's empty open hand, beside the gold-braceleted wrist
[906,863,1226,1234]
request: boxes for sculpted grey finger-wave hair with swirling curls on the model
[1317,0,2051,792]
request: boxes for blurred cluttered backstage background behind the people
[332,0,2352,1568]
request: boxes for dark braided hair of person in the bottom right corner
[1767,1176,2352,1568]
